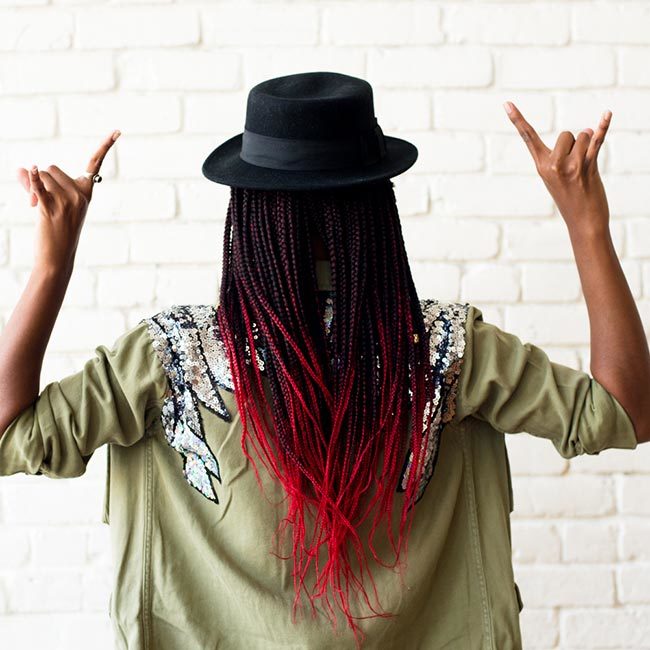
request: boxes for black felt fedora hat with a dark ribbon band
[201,72,418,190]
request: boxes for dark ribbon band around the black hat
[239,119,386,171]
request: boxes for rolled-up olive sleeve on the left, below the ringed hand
[0,321,167,478]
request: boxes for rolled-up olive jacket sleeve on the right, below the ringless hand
[455,305,638,458]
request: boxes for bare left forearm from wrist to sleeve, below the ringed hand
[0,268,70,436]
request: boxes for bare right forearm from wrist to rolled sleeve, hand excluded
[570,223,650,442]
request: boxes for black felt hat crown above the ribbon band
[244,72,377,139]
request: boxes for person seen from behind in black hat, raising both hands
[0,71,649,650]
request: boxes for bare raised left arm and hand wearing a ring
[0,131,119,436]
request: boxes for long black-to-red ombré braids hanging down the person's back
[217,179,433,644]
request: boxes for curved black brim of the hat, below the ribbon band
[201,133,418,190]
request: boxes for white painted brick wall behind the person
[0,0,650,650]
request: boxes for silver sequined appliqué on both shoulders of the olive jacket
[141,298,469,503]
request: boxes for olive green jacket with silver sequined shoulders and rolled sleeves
[0,260,637,650]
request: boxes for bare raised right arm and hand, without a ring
[504,102,650,443]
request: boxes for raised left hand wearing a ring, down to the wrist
[18,131,120,272]
